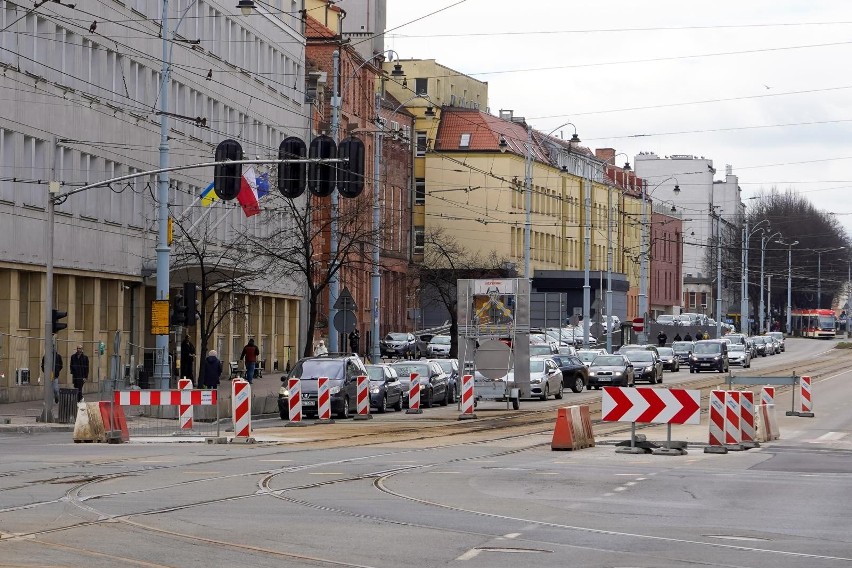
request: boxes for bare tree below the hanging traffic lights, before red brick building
[236,193,374,356]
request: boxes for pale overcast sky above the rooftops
[385,0,852,234]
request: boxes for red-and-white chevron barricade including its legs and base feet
[601,387,701,455]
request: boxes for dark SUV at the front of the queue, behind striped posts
[278,355,368,420]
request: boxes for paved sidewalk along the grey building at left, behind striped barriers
[0,372,283,433]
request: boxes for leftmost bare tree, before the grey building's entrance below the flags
[167,206,261,377]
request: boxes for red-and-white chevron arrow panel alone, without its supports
[601,387,701,424]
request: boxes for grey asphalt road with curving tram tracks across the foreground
[0,340,852,568]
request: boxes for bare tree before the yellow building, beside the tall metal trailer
[418,227,515,357]
